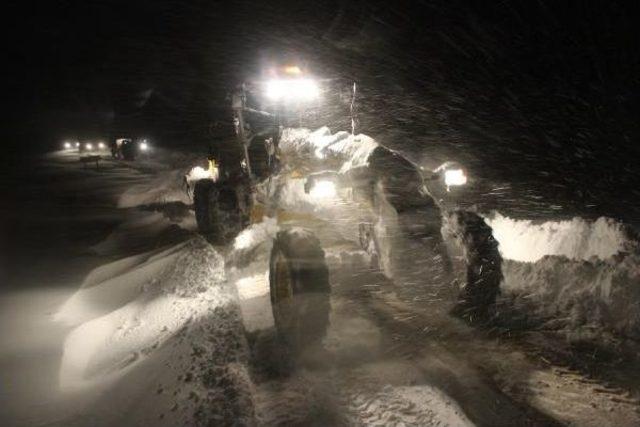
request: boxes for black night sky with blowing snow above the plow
[7,0,640,219]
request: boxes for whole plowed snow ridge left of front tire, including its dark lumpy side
[56,237,254,426]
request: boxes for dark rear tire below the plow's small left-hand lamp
[193,179,247,244]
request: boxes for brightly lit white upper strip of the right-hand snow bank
[485,212,637,262]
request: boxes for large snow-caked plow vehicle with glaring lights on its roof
[190,67,502,353]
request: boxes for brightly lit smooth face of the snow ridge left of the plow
[55,238,230,388]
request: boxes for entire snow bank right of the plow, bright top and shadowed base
[486,213,640,339]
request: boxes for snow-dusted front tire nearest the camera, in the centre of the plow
[269,228,331,355]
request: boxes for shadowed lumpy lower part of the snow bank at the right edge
[503,255,640,339]
